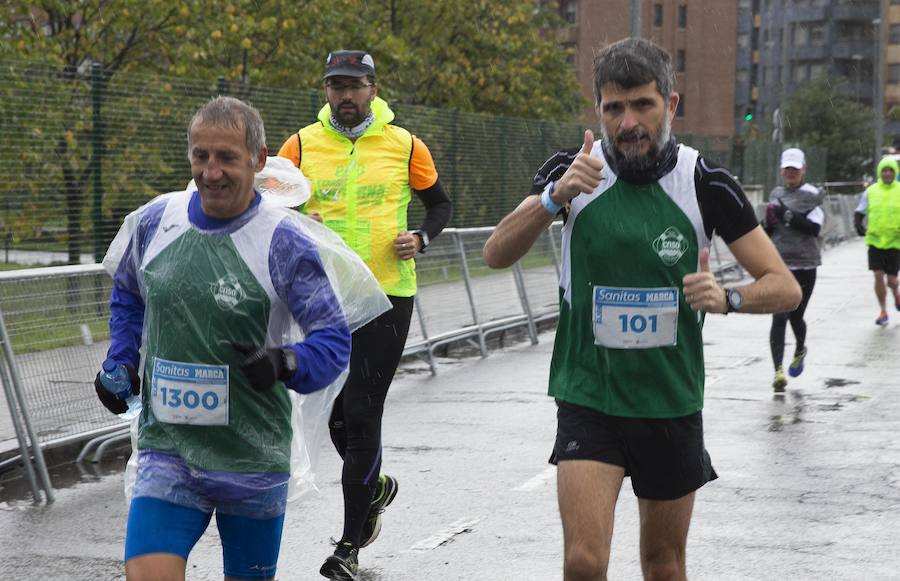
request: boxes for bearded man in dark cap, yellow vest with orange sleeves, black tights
[278,51,451,580]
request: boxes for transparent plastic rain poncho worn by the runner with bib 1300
[103,158,390,517]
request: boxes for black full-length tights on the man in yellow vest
[328,296,413,546]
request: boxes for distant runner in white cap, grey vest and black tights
[763,147,825,393]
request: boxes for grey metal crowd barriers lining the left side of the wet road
[0,196,856,503]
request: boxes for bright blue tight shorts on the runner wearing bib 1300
[125,496,284,579]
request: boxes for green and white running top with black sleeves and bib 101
[535,143,756,418]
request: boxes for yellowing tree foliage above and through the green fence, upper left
[0,0,584,262]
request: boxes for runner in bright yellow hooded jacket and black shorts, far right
[854,157,900,327]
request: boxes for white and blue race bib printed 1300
[150,357,228,426]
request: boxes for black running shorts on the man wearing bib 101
[550,400,718,500]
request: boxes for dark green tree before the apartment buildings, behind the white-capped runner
[784,78,874,181]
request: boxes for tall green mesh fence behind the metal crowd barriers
[0,62,824,263]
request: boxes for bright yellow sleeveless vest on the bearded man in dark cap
[299,97,416,297]
